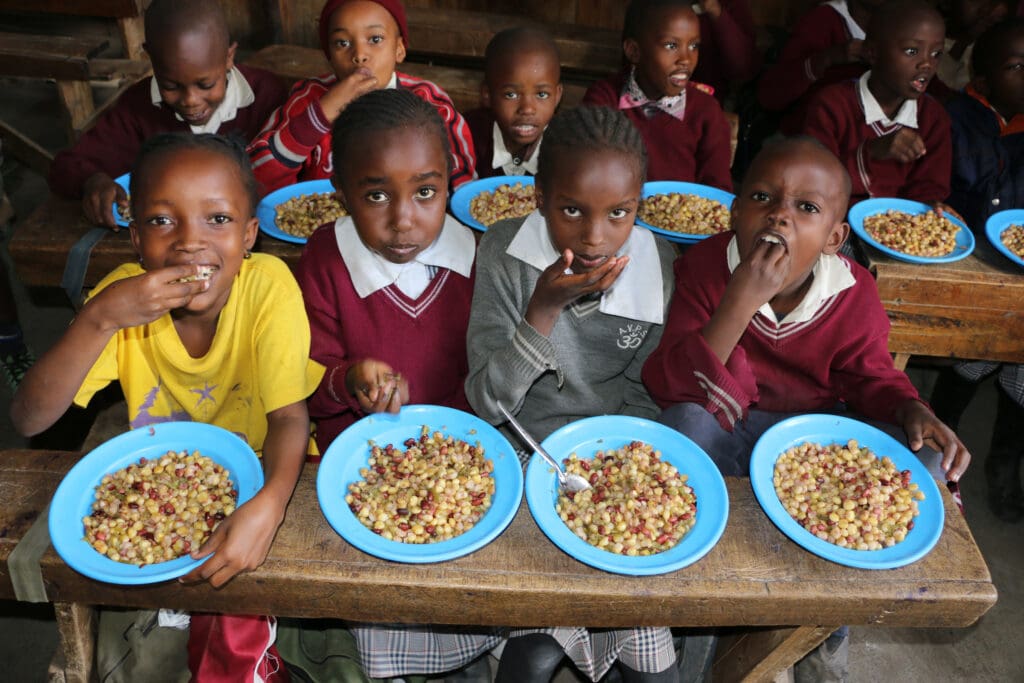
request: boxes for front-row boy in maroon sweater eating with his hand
[642,138,971,481]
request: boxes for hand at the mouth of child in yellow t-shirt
[87,264,210,330]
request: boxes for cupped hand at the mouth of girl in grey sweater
[526,249,630,337]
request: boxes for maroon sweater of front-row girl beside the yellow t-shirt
[295,223,475,454]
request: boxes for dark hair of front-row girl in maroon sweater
[331,88,452,183]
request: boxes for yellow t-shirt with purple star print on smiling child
[75,254,324,453]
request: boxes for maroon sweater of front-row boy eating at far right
[642,232,918,430]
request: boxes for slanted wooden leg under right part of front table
[712,626,839,683]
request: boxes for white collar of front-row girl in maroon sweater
[334,214,476,299]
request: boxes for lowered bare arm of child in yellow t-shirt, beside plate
[180,400,309,588]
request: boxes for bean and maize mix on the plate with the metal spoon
[555,441,697,555]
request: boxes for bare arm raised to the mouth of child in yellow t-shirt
[10,264,210,436]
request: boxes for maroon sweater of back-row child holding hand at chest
[804,80,952,206]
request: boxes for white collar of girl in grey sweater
[506,210,665,325]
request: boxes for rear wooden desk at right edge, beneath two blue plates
[861,239,1024,365]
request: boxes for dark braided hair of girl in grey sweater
[537,105,647,189]
